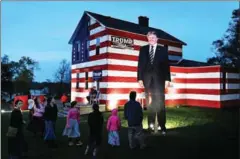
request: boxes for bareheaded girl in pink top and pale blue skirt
[63,101,83,146]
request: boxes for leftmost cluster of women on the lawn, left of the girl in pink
[7,97,58,159]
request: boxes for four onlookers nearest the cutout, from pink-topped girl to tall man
[63,91,146,157]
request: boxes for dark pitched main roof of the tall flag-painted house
[69,11,187,45]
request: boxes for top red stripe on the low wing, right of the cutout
[171,66,220,73]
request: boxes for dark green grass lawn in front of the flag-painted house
[1,107,239,159]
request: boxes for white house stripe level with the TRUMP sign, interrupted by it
[90,35,182,52]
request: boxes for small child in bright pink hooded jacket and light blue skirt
[107,109,121,146]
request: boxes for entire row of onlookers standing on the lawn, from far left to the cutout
[7,91,145,159]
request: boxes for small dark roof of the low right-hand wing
[171,59,210,67]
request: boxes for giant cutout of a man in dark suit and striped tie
[137,31,171,135]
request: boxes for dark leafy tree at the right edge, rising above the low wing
[207,9,240,68]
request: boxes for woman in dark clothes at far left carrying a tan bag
[8,100,27,159]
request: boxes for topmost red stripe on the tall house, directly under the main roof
[106,28,182,48]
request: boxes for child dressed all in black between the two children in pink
[85,104,103,157]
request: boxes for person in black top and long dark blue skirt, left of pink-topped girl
[44,97,58,148]
